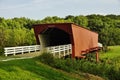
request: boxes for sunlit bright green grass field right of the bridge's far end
[100,46,120,75]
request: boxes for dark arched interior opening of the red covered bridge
[39,28,71,47]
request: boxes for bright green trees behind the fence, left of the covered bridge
[0,17,36,53]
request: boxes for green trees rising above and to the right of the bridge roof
[37,14,120,46]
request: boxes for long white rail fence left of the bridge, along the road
[4,45,40,56]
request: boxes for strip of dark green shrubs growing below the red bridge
[39,53,120,80]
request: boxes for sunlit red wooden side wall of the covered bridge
[72,24,98,57]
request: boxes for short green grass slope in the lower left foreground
[0,59,84,80]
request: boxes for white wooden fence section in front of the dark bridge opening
[46,44,72,58]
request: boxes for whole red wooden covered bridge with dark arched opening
[33,23,98,61]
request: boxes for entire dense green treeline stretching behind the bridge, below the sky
[0,14,120,53]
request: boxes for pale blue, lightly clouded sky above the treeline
[0,0,120,19]
